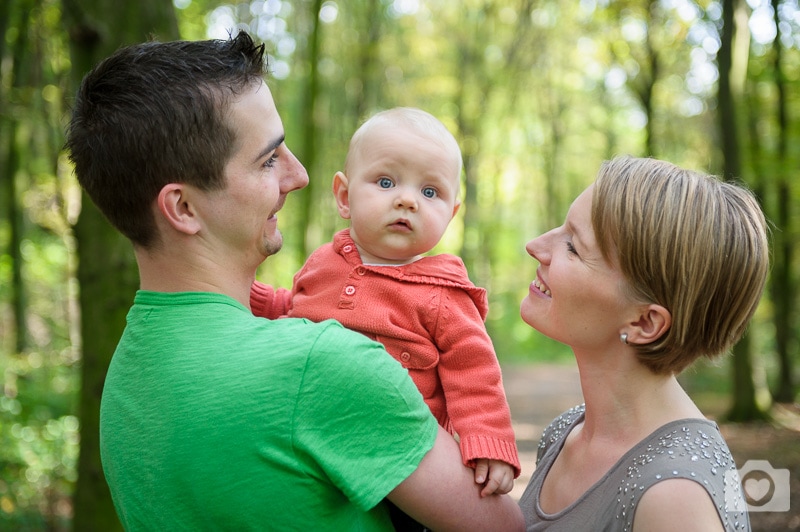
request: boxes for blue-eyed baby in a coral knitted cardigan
[251,108,520,502]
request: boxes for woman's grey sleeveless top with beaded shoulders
[519,405,750,532]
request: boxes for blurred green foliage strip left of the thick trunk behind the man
[0,0,79,530]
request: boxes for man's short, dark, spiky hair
[66,32,266,247]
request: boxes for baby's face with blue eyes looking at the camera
[340,127,460,264]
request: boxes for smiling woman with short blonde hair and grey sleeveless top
[520,157,769,532]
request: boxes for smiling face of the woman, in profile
[520,186,633,349]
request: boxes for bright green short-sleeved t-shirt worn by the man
[100,291,437,530]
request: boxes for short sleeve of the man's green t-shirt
[294,321,438,511]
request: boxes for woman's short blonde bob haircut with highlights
[592,157,769,374]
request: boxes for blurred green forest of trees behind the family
[0,0,800,530]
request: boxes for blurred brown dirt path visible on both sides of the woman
[503,364,800,532]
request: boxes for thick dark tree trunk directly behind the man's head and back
[63,0,178,531]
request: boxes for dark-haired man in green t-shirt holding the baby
[67,33,522,530]
